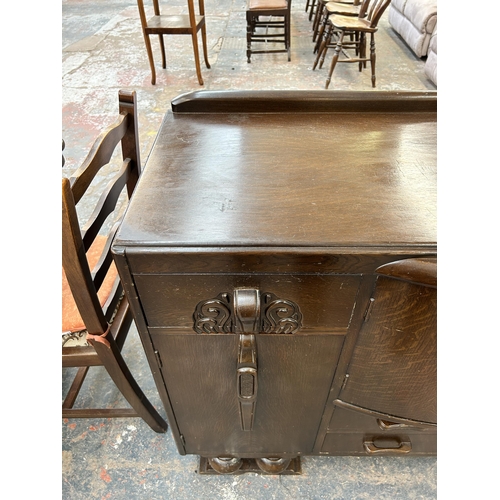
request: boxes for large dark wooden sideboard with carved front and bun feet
[113,91,437,473]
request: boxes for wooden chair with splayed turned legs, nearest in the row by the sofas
[313,0,391,89]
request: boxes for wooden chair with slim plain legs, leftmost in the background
[137,0,210,85]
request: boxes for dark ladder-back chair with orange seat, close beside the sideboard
[62,91,167,432]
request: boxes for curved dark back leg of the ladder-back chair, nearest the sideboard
[89,334,167,433]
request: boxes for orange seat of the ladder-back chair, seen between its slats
[62,236,118,333]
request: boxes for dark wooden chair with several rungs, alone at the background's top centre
[247,0,292,62]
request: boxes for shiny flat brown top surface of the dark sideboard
[115,91,437,248]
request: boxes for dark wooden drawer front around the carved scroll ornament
[134,274,361,335]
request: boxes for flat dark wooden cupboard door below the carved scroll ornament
[152,331,344,458]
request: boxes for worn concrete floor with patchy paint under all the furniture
[62,0,437,500]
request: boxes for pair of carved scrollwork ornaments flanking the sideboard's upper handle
[193,292,302,334]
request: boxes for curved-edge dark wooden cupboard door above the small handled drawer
[339,258,437,423]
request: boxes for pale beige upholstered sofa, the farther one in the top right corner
[389,0,437,57]
